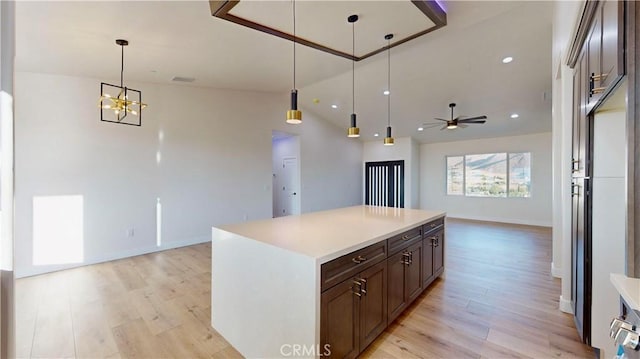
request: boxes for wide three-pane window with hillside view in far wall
[446,152,531,197]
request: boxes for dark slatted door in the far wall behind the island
[364,160,404,208]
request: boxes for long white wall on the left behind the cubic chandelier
[15,72,362,277]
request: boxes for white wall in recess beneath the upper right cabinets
[591,108,627,358]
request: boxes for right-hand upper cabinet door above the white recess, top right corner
[601,0,624,88]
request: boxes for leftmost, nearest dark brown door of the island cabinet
[320,279,360,358]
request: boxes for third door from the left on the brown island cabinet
[387,250,408,323]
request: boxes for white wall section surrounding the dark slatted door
[361,137,420,208]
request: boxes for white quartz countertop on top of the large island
[214,206,445,263]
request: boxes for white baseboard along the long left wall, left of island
[14,236,211,279]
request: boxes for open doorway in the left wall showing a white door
[271,131,301,218]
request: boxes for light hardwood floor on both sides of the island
[16,220,594,358]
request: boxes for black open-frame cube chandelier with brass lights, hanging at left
[99,39,147,126]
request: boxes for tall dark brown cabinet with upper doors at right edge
[568,0,628,344]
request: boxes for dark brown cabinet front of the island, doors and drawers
[320,217,444,358]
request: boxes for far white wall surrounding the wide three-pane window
[420,133,551,226]
